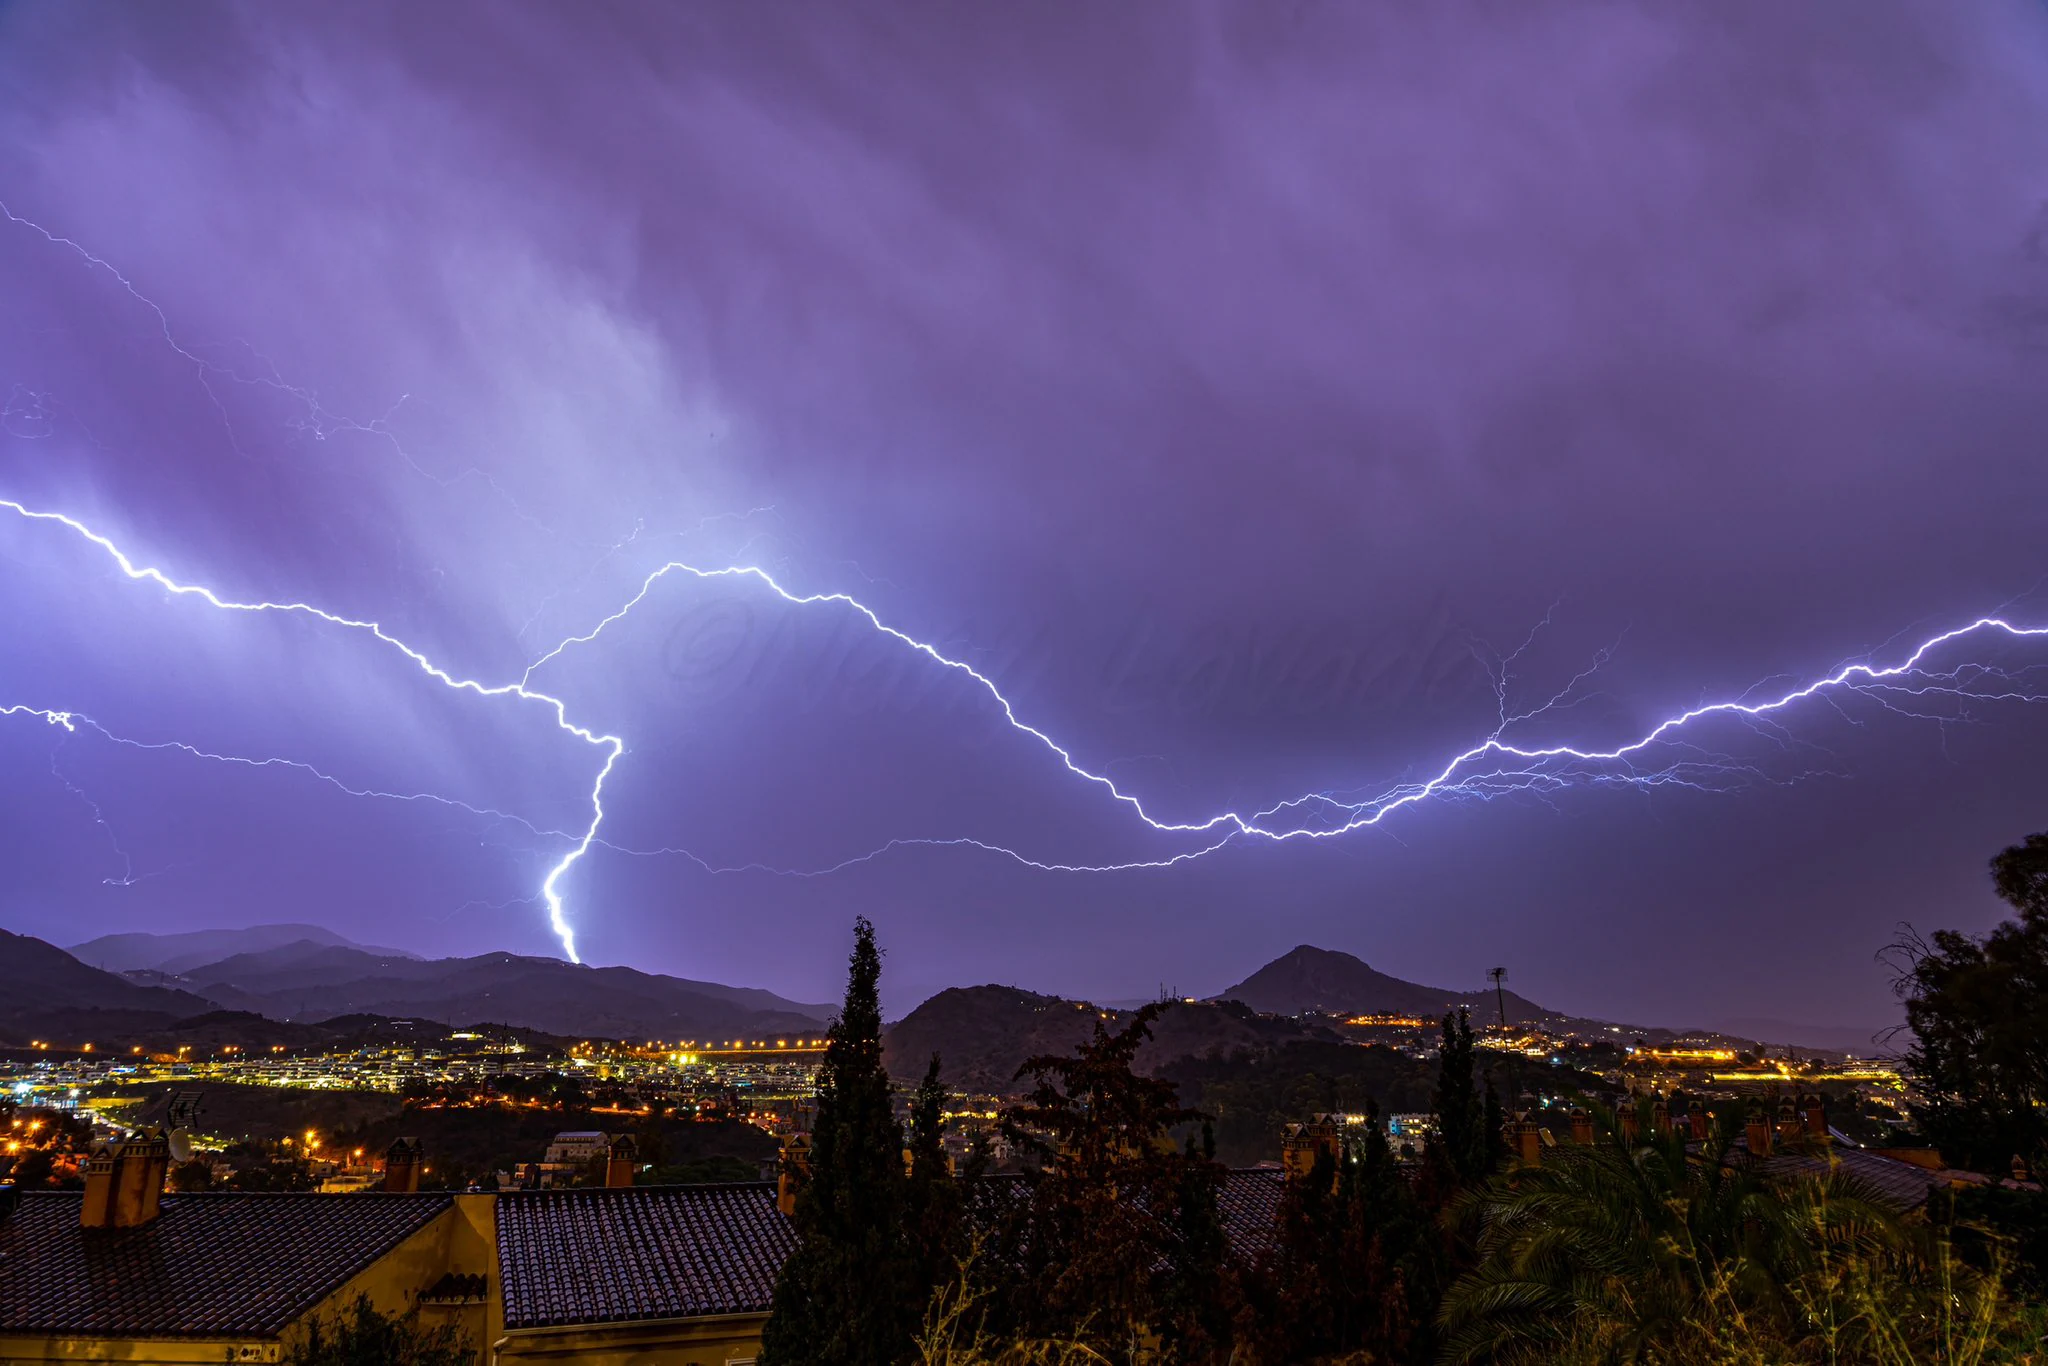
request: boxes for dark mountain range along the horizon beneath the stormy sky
[16,924,1843,1056]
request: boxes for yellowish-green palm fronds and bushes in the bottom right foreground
[1442,1141,2042,1366]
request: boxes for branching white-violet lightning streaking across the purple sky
[0,203,2048,961]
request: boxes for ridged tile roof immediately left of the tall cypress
[498,1182,797,1329]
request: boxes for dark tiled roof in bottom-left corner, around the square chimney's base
[0,1192,451,1337]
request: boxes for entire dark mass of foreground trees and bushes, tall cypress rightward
[764,810,2048,1366]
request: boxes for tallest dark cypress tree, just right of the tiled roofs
[762,917,924,1366]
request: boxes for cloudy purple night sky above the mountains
[0,0,2048,1024]
